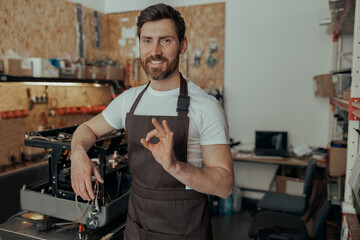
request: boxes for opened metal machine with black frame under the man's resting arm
[20,126,131,229]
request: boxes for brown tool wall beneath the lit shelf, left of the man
[0,83,111,166]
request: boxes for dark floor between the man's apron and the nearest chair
[211,203,255,240]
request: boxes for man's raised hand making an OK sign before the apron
[140,118,177,172]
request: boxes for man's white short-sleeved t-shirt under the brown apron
[102,81,229,168]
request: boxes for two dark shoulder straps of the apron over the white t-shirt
[129,73,190,117]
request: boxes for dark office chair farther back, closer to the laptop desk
[257,158,316,216]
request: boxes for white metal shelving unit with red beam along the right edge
[329,0,360,236]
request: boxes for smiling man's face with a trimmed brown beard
[140,19,186,80]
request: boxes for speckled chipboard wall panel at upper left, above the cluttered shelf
[0,0,107,59]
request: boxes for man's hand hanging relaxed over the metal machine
[71,148,104,201]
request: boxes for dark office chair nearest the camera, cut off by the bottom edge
[248,199,331,240]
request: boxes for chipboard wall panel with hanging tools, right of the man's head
[178,3,225,89]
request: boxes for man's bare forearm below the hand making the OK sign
[169,161,234,198]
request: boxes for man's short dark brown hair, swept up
[136,3,186,42]
